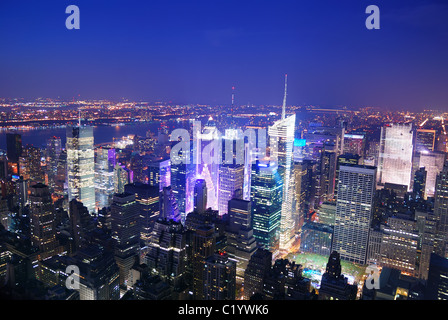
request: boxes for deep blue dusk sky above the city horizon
[0,0,448,110]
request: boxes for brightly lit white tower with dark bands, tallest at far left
[66,126,95,214]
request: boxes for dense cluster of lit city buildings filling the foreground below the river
[0,99,448,300]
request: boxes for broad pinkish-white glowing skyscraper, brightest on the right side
[377,123,413,190]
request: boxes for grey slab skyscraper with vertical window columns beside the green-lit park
[332,165,376,264]
